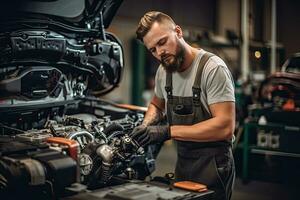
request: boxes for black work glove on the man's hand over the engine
[130,125,171,147]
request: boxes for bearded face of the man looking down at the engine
[143,22,184,72]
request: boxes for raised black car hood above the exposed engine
[0,0,124,102]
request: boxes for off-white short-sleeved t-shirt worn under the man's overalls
[154,49,235,113]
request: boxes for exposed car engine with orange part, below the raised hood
[0,98,159,198]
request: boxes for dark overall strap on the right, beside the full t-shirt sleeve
[192,52,214,106]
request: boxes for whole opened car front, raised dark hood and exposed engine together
[0,0,160,199]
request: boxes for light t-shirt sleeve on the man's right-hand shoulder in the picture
[205,65,235,105]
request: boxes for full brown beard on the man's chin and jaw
[161,43,184,73]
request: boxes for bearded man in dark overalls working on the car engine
[131,11,235,199]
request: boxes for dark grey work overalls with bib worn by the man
[165,53,235,200]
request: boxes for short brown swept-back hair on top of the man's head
[135,11,175,42]
